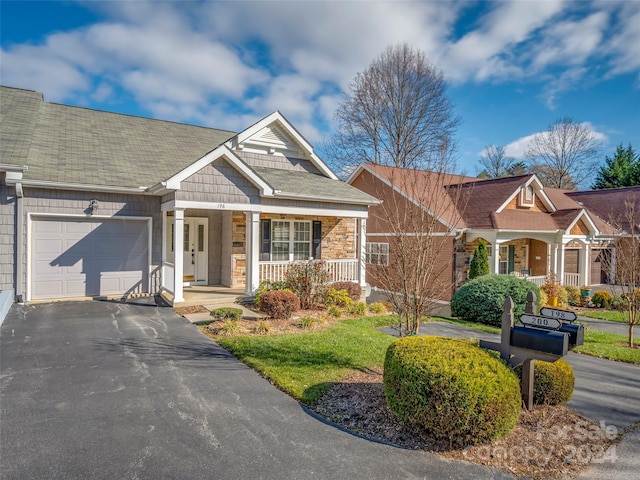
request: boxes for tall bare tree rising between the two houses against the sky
[331,43,460,171]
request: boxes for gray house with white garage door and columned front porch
[0,87,377,303]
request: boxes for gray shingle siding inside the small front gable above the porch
[176,159,260,203]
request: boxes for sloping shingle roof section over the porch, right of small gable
[251,167,378,204]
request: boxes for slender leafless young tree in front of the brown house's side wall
[367,153,469,335]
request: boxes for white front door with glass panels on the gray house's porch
[183,218,209,286]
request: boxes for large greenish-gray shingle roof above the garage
[0,87,235,187]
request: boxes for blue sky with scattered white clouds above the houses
[0,0,640,180]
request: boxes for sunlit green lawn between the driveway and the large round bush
[217,315,396,404]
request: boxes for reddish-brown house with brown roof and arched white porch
[348,164,628,300]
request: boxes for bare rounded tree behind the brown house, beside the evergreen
[525,117,601,188]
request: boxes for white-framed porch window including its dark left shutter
[260,220,312,262]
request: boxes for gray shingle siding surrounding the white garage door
[14,187,162,292]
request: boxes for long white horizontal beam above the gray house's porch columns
[169,200,369,218]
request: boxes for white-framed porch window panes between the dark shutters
[263,220,312,262]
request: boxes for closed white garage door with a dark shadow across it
[31,218,149,299]
